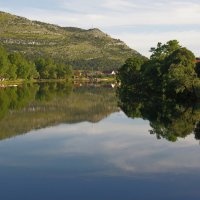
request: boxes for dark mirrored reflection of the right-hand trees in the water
[118,87,200,142]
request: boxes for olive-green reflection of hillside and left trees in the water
[0,83,118,139]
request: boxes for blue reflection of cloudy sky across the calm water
[0,112,200,199]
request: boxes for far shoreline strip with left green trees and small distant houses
[0,46,116,87]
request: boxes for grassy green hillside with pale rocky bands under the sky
[0,12,141,70]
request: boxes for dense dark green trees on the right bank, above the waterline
[118,40,200,101]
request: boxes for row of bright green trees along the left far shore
[0,46,72,80]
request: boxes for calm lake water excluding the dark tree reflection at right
[0,84,200,200]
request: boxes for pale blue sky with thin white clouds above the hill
[0,0,200,56]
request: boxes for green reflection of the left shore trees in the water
[0,83,72,118]
